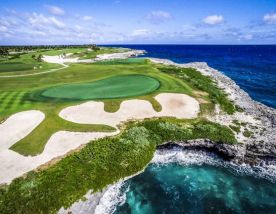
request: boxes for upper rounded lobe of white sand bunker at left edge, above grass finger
[0,110,45,151]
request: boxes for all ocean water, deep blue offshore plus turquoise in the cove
[99,45,276,214]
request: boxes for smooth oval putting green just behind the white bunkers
[41,75,159,100]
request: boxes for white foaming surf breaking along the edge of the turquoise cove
[62,149,276,214]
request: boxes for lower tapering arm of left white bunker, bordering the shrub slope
[0,131,118,183]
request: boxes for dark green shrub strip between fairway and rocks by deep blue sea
[159,66,235,114]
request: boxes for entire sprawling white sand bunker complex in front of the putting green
[0,93,199,183]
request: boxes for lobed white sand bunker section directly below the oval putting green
[59,93,199,127]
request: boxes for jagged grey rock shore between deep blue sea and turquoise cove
[148,58,276,165]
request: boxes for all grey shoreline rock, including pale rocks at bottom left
[59,55,276,214]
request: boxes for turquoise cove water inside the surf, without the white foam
[115,163,276,214]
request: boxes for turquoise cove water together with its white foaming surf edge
[95,149,276,214]
